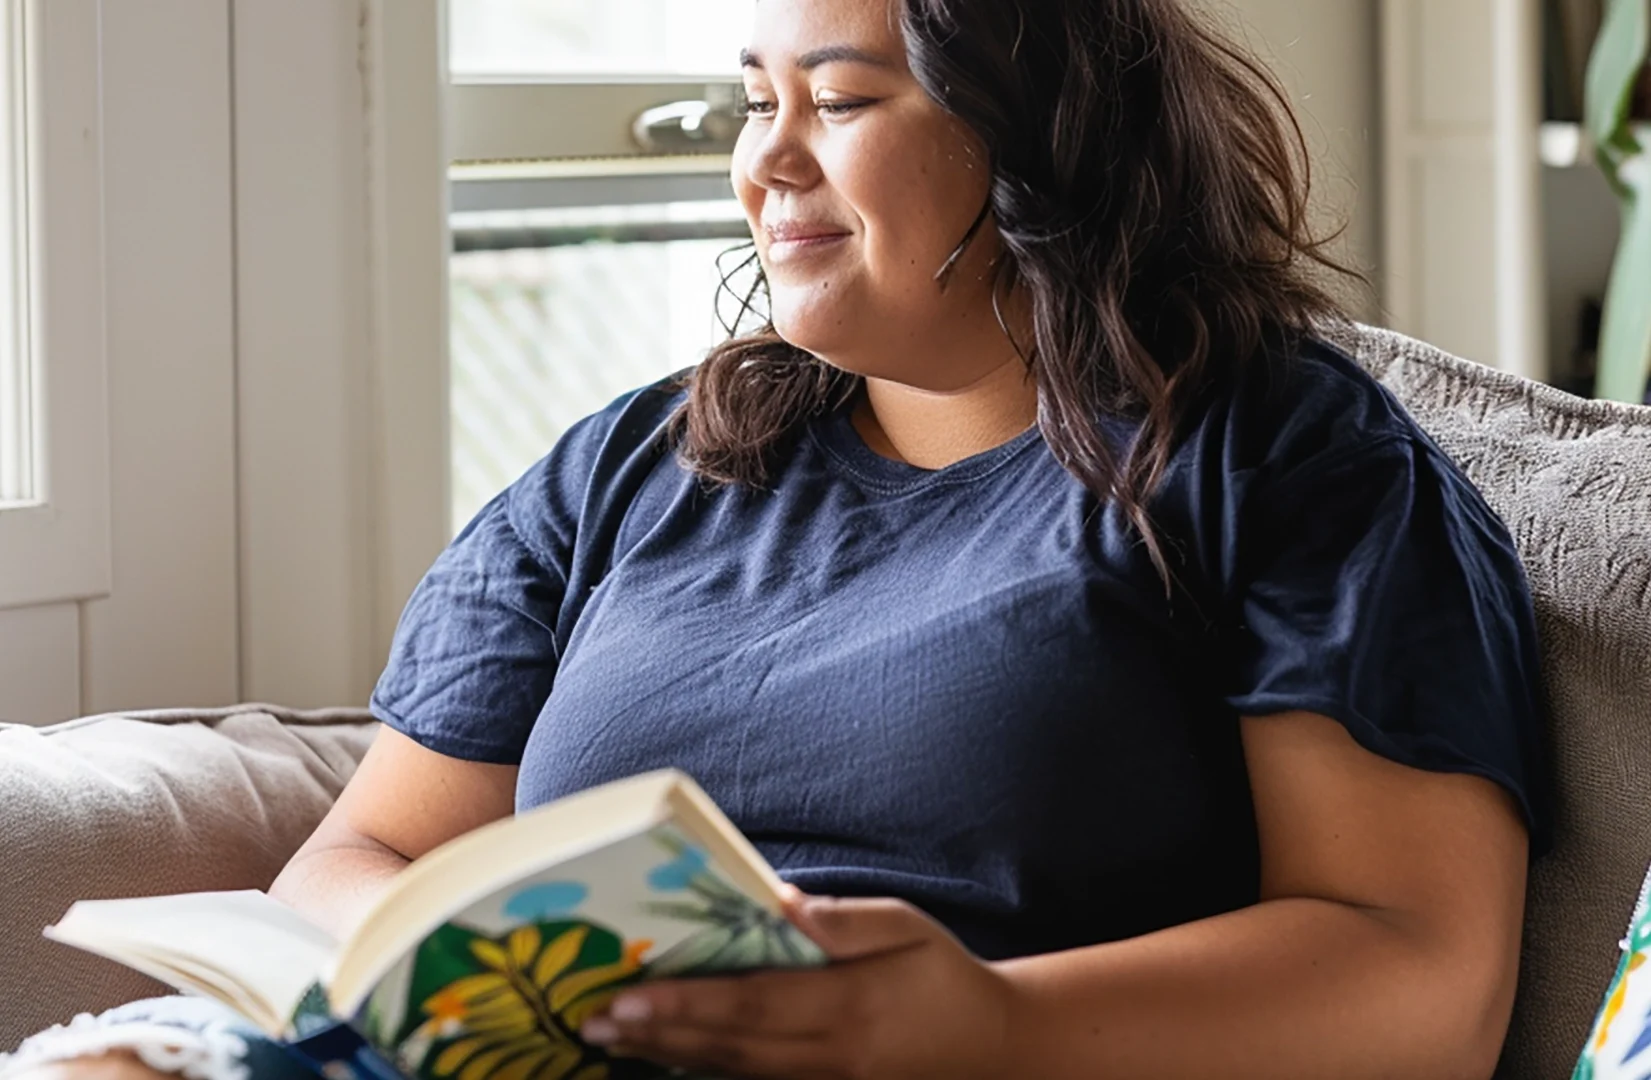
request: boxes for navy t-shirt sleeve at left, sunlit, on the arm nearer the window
[371,454,573,765]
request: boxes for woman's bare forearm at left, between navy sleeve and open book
[269,727,517,938]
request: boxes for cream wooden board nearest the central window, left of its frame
[231,0,378,707]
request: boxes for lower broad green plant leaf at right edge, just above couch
[1595,150,1651,405]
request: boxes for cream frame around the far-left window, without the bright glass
[0,0,112,609]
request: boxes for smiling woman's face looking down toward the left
[733,0,1004,391]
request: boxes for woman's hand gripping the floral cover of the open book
[581,893,1014,1080]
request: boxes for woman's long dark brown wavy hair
[672,0,1359,591]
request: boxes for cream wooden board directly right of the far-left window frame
[78,0,241,712]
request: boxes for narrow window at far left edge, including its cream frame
[0,0,111,608]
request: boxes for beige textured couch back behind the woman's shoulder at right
[1342,323,1651,1080]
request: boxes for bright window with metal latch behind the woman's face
[447,0,753,528]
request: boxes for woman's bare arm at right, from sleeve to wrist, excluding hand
[999,713,1527,1080]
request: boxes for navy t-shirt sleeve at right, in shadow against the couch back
[1228,434,1547,846]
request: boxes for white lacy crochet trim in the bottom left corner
[0,1012,251,1080]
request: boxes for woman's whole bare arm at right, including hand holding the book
[588,713,1527,1080]
